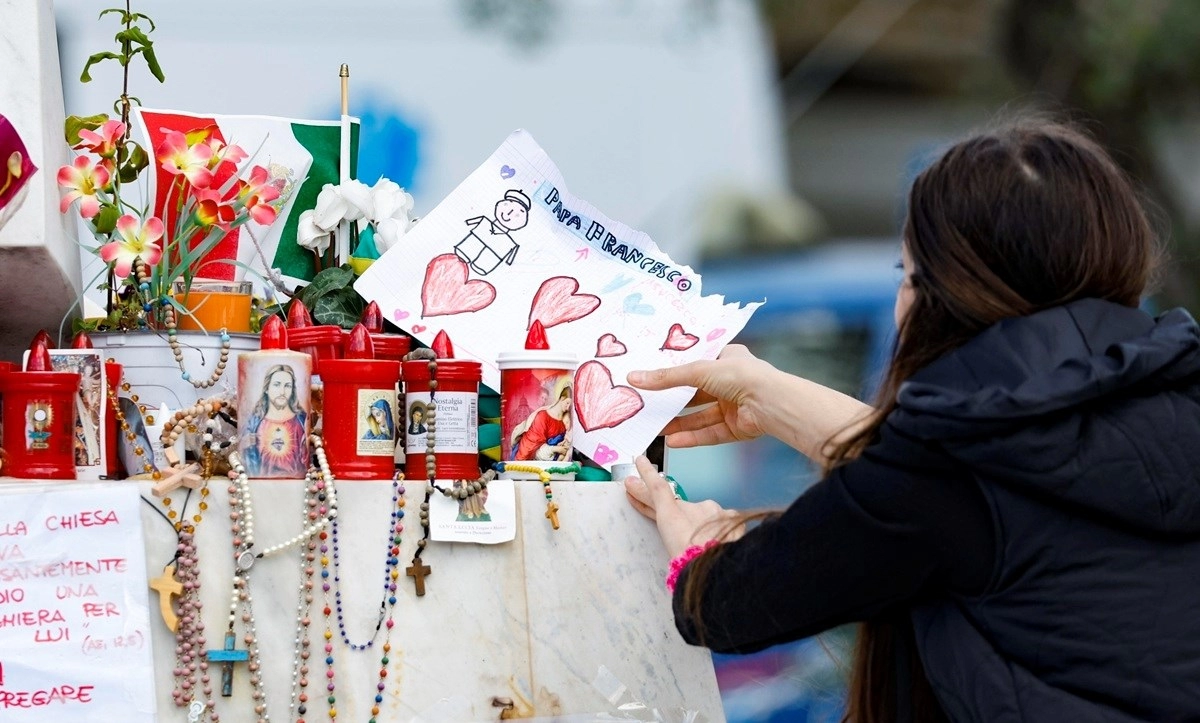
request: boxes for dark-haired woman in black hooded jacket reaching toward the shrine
[625,125,1200,723]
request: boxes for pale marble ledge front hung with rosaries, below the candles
[0,479,725,723]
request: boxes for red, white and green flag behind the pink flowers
[134,108,359,288]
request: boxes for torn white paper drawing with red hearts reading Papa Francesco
[355,131,760,467]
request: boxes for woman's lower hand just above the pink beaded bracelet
[625,456,745,557]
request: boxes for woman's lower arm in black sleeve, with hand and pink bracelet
[626,422,996,652]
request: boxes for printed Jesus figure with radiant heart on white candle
[240,364,308,478]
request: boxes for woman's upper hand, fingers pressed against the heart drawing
[628,343,776,447]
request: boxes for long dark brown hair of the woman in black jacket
[685,120,1159,723]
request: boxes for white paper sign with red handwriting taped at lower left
[0,484,155,723]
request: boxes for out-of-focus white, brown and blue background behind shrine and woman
[39,0,1200,722]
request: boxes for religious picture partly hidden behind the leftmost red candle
[22,349,113,479]
